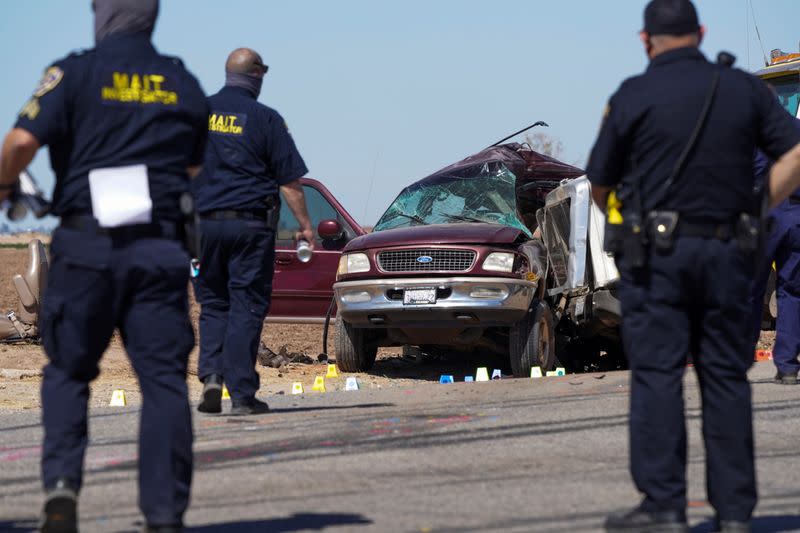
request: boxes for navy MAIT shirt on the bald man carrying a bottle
[194,87,308,213]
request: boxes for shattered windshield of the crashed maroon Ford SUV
[374,163,530,235]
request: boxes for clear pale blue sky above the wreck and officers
[0,0,800,229]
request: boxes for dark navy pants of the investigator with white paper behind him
[40,224,194,525]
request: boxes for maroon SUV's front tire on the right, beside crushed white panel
[508,300,556,378]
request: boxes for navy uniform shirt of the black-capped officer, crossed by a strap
[587,48,800,223]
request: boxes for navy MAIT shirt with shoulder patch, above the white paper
[16,34,208,220]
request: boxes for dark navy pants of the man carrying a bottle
[195,220,275,401]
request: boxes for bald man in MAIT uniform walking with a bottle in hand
[194,48,314,415]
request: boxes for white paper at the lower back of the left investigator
[89,165,153,228]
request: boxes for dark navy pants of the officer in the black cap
[618,238,757,520]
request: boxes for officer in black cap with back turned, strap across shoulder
[587,0,800,532]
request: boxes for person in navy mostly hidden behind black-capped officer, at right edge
[753,120,800,385]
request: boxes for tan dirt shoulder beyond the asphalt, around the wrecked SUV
[0,248,774,411]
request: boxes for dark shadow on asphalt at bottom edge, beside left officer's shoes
[186,513,372,533]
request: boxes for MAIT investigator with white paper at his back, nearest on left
[0,0,208,532]
